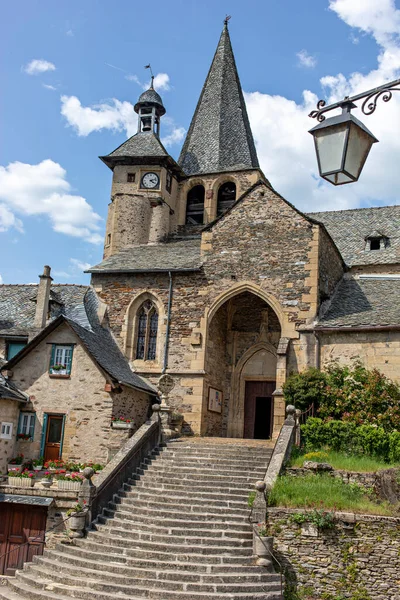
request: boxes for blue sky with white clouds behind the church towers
[0,0,400,283]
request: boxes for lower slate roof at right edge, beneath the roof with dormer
[316,274,400,329]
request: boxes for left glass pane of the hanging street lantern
[314,123,348,176]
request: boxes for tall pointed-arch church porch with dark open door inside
[202,292,281,439]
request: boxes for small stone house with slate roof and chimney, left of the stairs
[0,267,157,472]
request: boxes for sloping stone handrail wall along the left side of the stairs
[87,413,160,520]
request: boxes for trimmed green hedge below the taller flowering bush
[301,417,400,463]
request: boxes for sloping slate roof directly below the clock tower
[88,238,201,273]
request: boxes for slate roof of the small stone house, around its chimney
[0,285,157,399]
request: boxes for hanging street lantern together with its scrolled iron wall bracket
[309,79,400,185]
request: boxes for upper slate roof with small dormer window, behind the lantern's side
[308,206,400,267]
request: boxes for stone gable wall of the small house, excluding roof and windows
[8,324,149,464]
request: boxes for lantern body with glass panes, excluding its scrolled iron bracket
[309,102,378,185]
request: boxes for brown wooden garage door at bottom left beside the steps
[0,502,47,575]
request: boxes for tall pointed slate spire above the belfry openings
[178,20,259,175]
